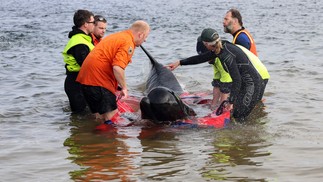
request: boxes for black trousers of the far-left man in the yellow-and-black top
[64,74,86,113]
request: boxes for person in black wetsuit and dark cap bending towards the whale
[167,28,262,121]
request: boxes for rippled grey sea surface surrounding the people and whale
[0,0,323,182]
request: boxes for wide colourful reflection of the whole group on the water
[64,109,271,181]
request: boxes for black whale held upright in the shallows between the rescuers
[140,46,196,124]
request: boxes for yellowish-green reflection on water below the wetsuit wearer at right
[202,125,272,181]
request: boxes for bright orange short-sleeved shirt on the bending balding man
[76,30,135,93]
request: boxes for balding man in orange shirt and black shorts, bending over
[76,20,150,124]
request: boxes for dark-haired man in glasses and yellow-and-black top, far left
[63,10,95,113]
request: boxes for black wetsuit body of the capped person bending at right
[217,41,263,119]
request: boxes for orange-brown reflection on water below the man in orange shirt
[64,114,142,181]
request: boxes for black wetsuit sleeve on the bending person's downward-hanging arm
[224,55,242,104]
